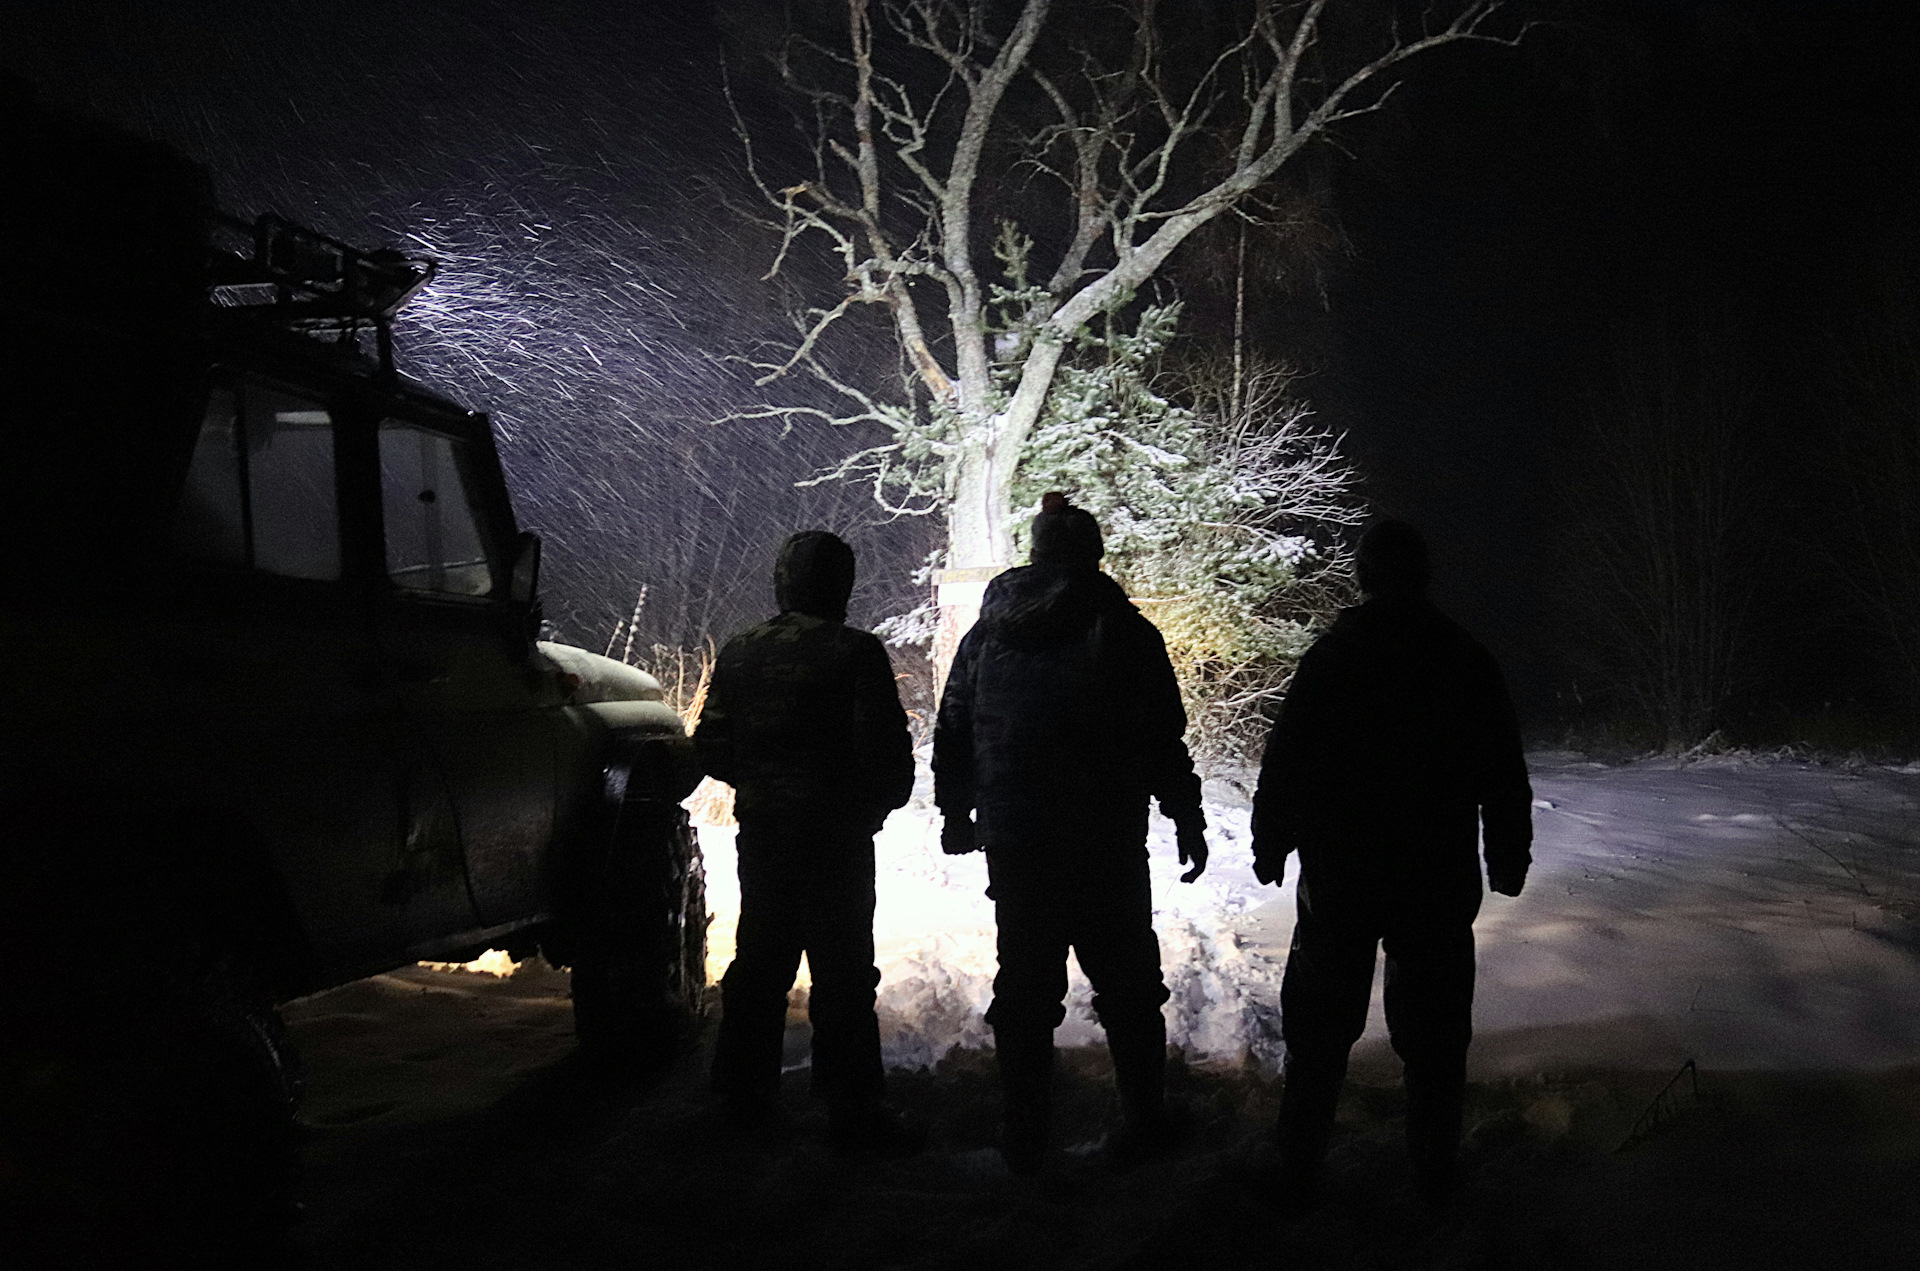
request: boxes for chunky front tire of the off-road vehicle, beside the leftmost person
[572,799,707,1077]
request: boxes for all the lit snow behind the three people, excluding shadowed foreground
[701,753,1920,1077]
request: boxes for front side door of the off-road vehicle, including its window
[376,411,561,927]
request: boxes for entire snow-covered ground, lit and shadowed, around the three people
[284,755,1920,1271]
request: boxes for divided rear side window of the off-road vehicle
[173,380,340,580]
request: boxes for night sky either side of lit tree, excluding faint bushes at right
[15,0,1920,726]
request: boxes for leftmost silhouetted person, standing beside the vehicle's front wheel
[693,530,924,1150]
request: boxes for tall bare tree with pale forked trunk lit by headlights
[733,0,1519,649]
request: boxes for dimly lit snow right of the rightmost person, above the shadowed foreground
[1475,755,1920,1073]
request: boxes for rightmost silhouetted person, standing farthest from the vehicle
[1254,520,1532,1210]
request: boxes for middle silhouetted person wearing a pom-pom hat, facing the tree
[933,493,1206,1173]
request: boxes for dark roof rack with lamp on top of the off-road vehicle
[207,211,436,374]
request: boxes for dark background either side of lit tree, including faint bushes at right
[11,0,1920,751]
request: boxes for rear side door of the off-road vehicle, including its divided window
[166,372,474,977]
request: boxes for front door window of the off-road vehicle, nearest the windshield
[380,419,493,595]
